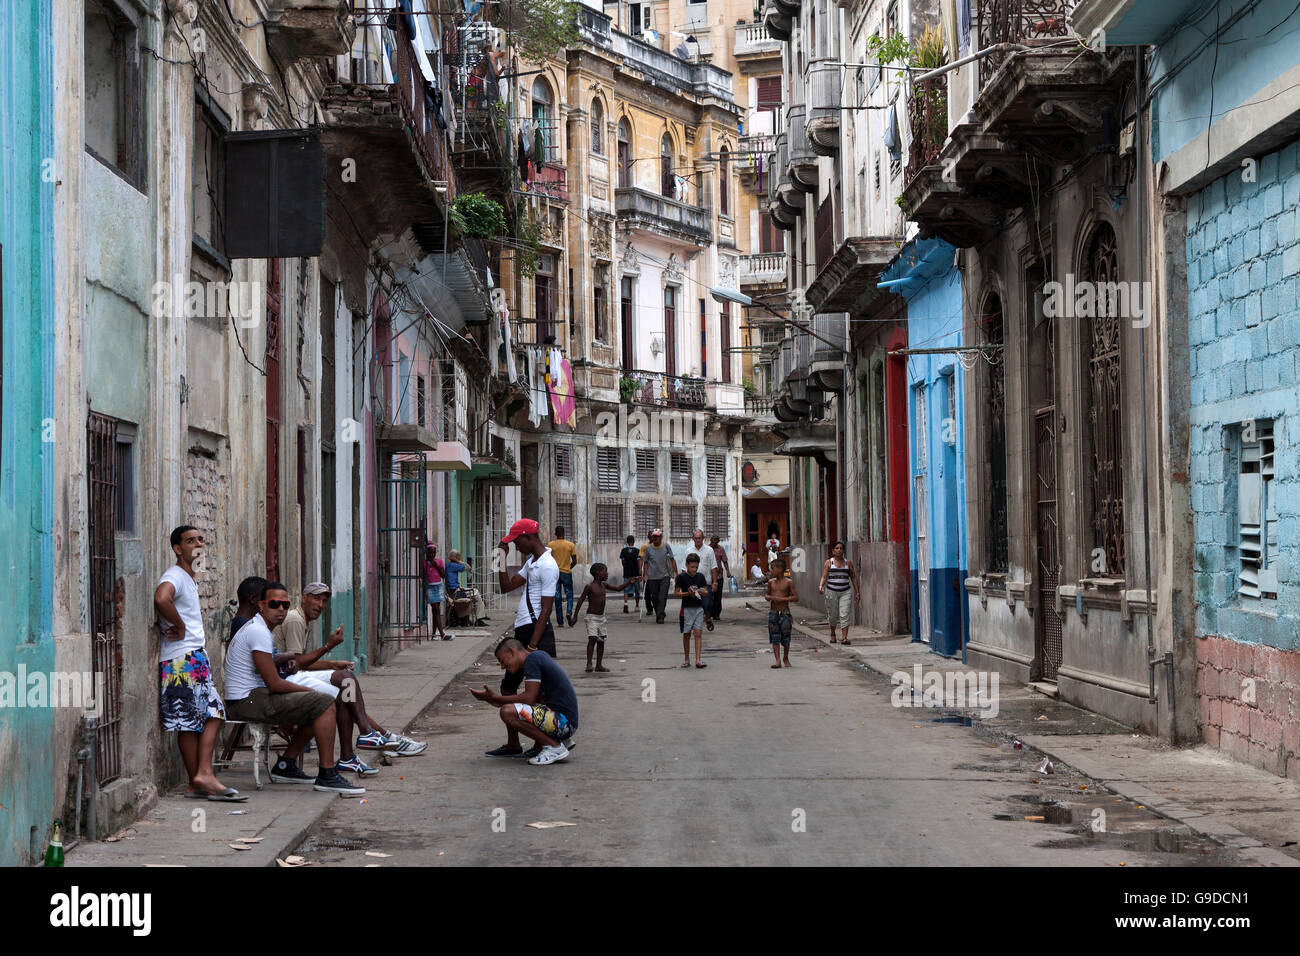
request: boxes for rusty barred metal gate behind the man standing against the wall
[86,414,122,784]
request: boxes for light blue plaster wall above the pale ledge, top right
[1149,0,1300,161]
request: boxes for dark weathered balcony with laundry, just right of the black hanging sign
[321,23,456,254]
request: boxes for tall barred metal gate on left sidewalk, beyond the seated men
[378,453,428,656]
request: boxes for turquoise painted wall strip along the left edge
[0,0,64,866]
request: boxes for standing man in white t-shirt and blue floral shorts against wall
[153,524,248,803]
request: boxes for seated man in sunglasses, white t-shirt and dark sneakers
[226,581,365,796]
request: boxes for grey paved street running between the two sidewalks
[299,602,1234,866]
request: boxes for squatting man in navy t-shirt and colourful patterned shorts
[469,637,577,766]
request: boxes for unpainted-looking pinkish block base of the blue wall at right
[1196,637,1300,783]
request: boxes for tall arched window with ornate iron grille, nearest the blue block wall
[1082,222,1125,578]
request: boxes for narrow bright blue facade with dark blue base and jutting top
[881,239,970,656]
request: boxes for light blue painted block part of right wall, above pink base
[1186,142,1300,649]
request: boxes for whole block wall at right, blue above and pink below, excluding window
[1186,142,1300,780]
